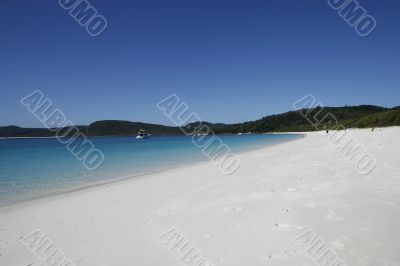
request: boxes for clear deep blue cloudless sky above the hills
[0,0,400,127]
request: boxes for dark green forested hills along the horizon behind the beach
[0,105,400,138]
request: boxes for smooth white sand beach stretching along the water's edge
[0,128,400,266]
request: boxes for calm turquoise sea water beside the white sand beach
[0,134,301,205]
